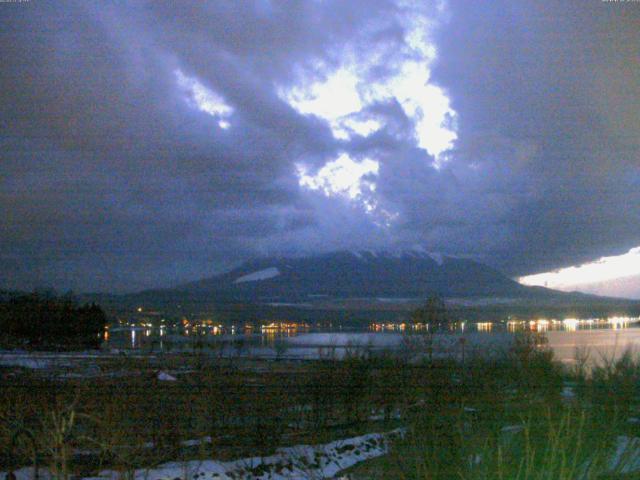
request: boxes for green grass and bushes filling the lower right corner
[350,340,640,480]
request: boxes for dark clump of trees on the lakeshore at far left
[0,293,107,350]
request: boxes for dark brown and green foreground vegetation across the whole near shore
[0,336,640,479]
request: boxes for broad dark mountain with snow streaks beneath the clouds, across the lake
[148,250,567,302]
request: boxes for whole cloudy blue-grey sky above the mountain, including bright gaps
[0,0,640,297]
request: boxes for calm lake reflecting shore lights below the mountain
[105,317,640,364]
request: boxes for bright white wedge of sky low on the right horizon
[518,247,640,291]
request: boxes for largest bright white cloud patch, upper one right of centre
[279,3,457,167]
